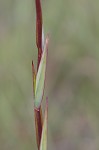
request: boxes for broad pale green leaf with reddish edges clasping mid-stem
[34,37,48,109]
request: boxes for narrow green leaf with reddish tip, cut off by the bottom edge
[40,98,48,150]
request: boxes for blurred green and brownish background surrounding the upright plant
[0,0,99,150]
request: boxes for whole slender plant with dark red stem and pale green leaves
[32,0,48,150]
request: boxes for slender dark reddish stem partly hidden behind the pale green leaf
[32,0,42,150]
